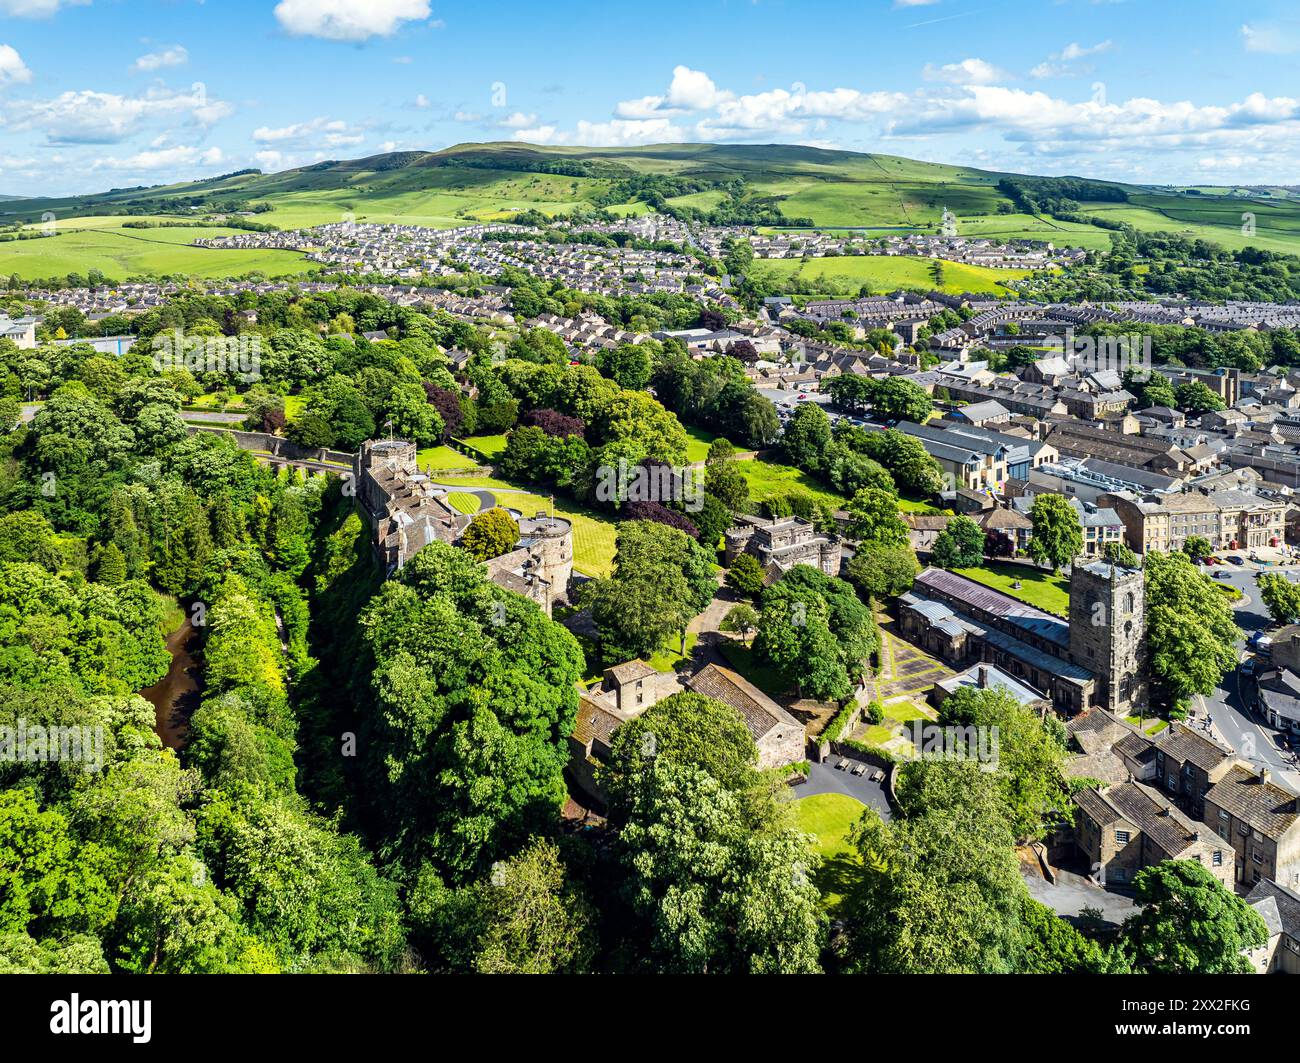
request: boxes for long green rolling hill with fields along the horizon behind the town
[0,142,1300,277]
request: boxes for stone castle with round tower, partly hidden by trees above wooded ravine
[354,439,573,616]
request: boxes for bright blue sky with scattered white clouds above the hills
[0,0,1300,195]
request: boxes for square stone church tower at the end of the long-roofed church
[1070,561,1147,716]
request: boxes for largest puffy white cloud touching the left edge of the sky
[8,88,234,144]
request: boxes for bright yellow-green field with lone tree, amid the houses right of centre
[754,255,1032,295]
